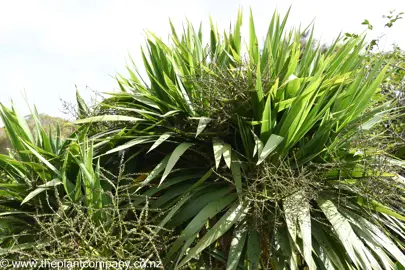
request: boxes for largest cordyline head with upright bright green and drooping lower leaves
[71,8,405,269]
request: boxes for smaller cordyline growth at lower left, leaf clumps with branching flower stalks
[0,104,170,261]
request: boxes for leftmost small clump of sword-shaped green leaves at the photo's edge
[0,105,65,254]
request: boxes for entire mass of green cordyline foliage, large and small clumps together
[0,8,405,269]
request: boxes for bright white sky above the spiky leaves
[0,0,405,117]
